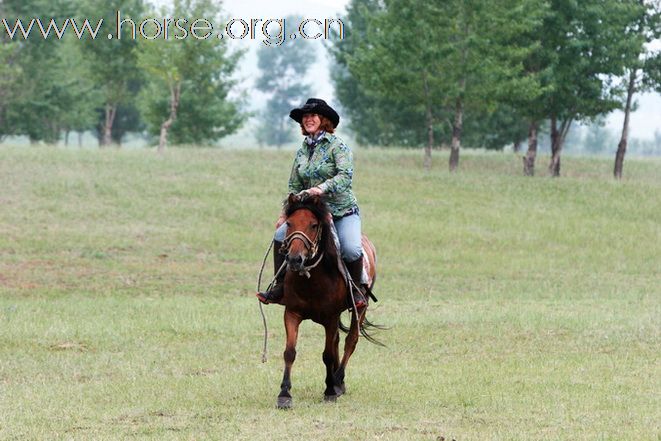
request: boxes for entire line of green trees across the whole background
[0,0,661,176]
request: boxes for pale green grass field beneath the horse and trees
[0,148,661,441]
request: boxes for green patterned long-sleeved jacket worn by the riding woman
[289,133,358,217]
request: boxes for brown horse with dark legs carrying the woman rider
[277,195,376,409]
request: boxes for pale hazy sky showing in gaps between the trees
[155,0,661,138]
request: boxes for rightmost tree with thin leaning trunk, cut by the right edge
[613,0,661,179]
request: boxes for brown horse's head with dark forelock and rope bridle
[283,194,329,271]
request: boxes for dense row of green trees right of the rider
[333,0,661,176]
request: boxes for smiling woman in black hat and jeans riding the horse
[257,98,367,309]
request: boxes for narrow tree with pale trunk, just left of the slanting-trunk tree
[81,0,144,146]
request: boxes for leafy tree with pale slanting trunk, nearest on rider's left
[139,0,242,152]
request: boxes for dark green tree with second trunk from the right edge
[538,0,637,176]
